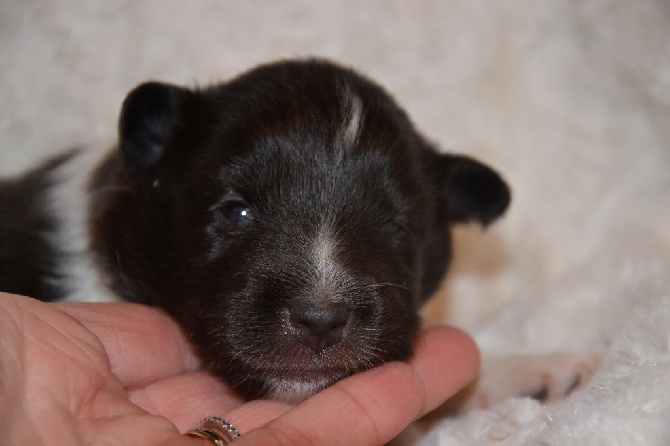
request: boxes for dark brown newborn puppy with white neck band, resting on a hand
[0,60,510,401]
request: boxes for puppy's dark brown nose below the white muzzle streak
[290,303,349,353]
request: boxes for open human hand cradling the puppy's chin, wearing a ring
[0,293,479,446]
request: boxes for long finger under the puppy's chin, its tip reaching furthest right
[225,327,479,446]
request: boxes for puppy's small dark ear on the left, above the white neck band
[119,82,186,172]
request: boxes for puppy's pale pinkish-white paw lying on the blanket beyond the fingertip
[461,353,600,410]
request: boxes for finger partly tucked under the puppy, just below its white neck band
[55,302,198,388]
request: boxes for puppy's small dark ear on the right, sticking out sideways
[437,155,511,226]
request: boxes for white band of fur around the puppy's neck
[46,148,119,302]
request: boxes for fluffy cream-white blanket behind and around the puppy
[0,0,670,445]
